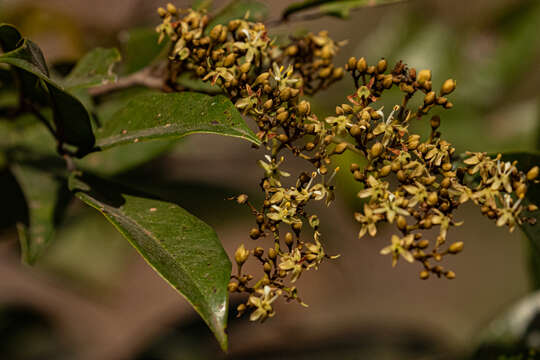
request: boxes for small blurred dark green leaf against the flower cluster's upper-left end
[120,27,168,74]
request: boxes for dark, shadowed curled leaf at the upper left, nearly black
[0,24,95,156]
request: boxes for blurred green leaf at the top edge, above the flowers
[282,0,405,19]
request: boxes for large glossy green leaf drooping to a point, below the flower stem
[69,174,231,350]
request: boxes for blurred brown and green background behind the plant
[0,0,540,360]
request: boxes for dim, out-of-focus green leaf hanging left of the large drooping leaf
[11,164,70,264]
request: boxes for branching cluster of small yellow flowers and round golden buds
[157,4,538,321]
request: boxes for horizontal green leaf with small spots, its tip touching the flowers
[96,92,260,149]
